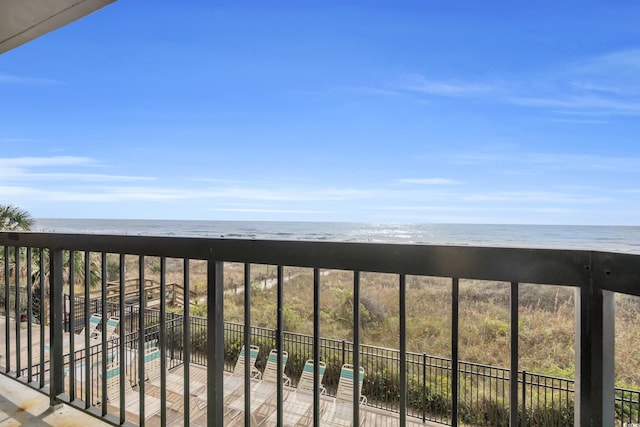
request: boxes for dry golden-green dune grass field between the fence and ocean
[92,257,640,388]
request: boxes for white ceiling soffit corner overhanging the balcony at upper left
[0,0,115,53]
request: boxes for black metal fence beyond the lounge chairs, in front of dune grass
[65,297,640,426]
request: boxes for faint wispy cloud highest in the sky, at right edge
[384,49,640,117]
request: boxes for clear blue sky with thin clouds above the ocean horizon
[0,0,640,225]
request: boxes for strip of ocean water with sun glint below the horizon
[34,218,640,254]
